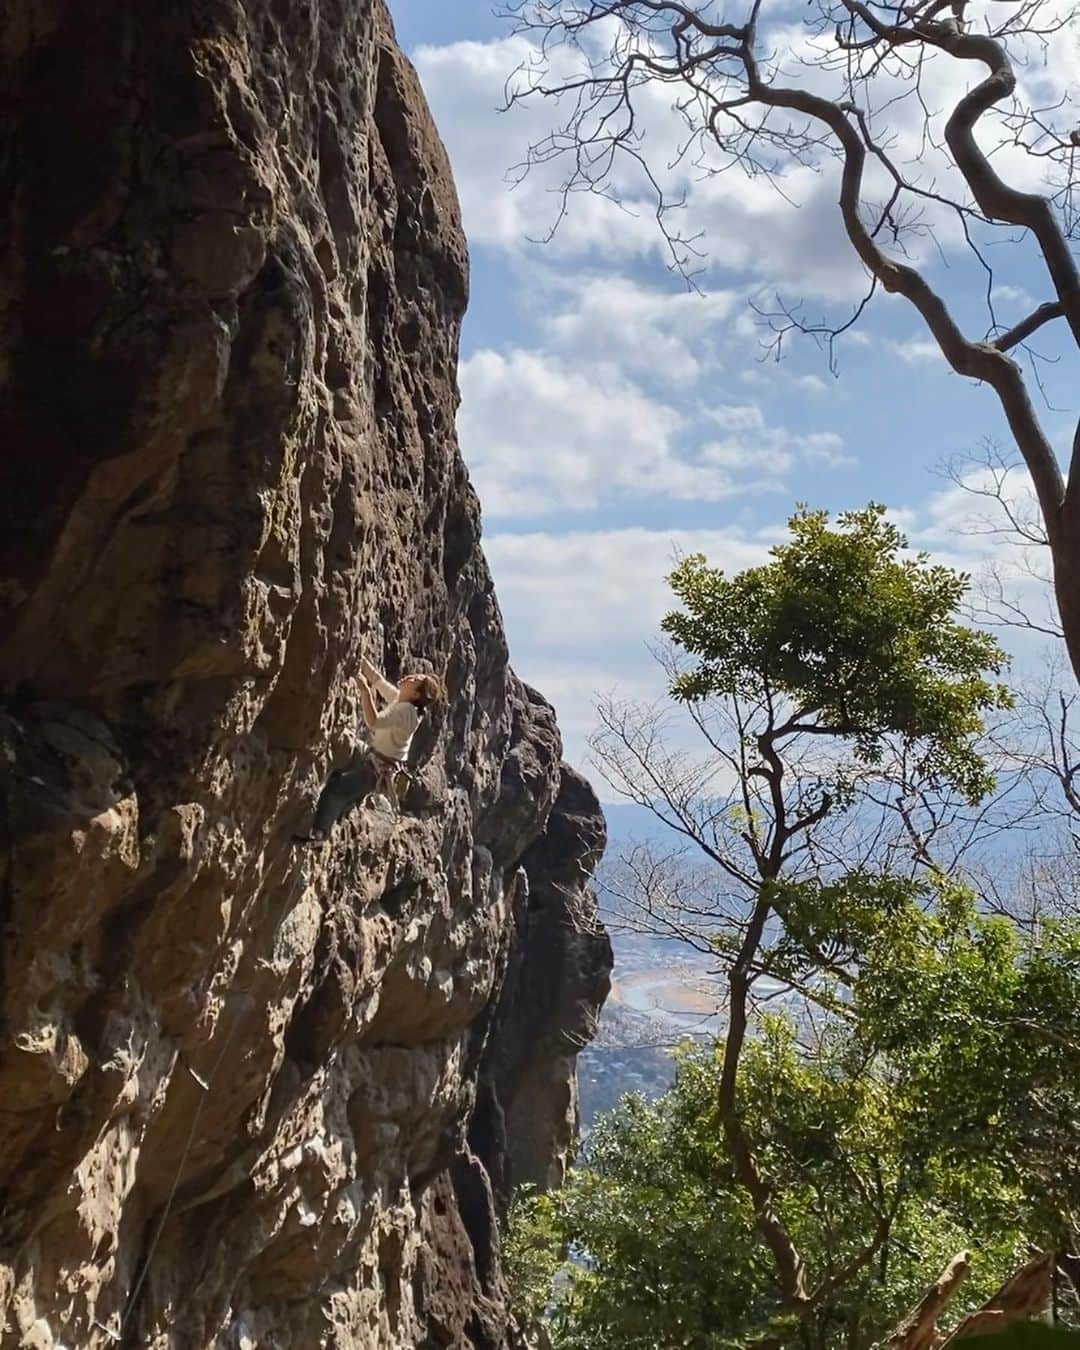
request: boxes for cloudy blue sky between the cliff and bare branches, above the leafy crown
[390,0,1076,788]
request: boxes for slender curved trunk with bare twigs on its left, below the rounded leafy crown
[593,685,853,1314]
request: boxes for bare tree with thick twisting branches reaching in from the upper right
[504,0,1080,675]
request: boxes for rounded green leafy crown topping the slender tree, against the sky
[663,504,1010,801]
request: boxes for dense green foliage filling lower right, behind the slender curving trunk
[507,876,1080,1350]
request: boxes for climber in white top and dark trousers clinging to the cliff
[296,657,446,844]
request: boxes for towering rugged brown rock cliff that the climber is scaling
[0,0,610,1350]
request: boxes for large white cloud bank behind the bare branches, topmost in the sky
[414,12,1075,326]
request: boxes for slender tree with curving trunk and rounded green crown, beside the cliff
[595,505,1008,1316]
